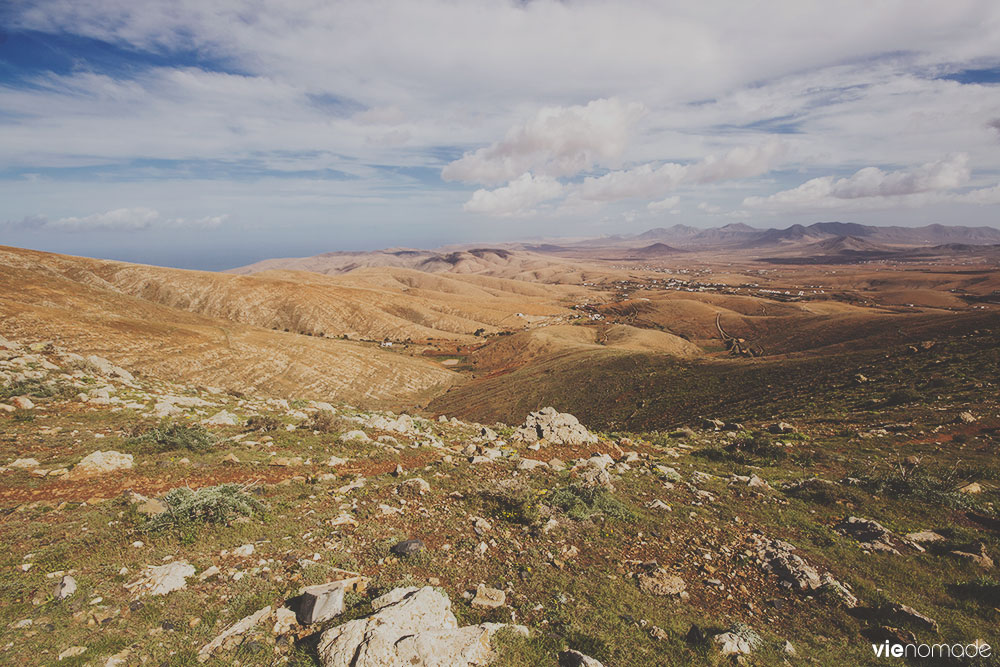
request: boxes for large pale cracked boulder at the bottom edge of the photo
[318,586,527,667]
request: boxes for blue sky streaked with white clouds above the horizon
[0,0,1000,270]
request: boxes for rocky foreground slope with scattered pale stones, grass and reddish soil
[0,339,1000,667]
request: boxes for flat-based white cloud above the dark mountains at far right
[743,153,970,208]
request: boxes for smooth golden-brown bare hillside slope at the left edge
[0,248,456,405]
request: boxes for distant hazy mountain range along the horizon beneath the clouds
[230,222,1000,282]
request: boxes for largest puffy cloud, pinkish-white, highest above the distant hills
[441,98,645,185]
